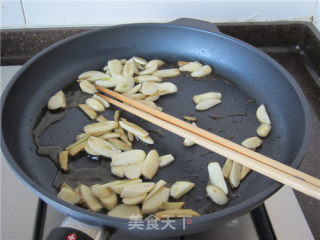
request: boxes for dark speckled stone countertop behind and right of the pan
[1,22,320,238]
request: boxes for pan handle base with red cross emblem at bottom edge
[46,217,114,240]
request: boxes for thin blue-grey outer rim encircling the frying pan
[1,23,311,232]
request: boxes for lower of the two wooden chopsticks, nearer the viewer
[98,89,320,200]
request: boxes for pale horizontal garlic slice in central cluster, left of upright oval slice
[111,149,146,166]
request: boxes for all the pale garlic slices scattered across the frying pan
[48,57,271,219]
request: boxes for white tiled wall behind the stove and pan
[2,0,319,28]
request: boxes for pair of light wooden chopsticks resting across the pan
[95,85,320,200]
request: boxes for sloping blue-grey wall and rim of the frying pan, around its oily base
[1,19,310,236]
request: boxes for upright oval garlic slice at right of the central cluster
[141,149,160,179]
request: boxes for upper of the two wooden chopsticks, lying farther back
[95,85,320,187]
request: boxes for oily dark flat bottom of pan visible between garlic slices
[34,61,258,214]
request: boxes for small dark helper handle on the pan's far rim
[169,18,221,33]
